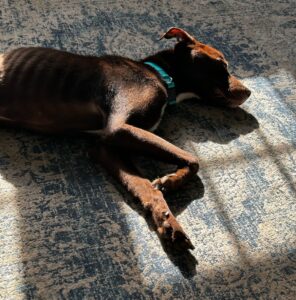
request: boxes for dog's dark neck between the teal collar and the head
[141,49,199,103]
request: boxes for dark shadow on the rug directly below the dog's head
[157,99,259,147]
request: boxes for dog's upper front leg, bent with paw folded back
[104,124,198,191]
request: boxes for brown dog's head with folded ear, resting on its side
[162,27,251,107]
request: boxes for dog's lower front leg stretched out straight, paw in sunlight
[90,145,194,250]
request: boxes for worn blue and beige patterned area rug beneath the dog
[0,0,296,299]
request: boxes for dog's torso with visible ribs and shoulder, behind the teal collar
[0,47,165,132]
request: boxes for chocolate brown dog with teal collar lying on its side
[0,28,250,249]
